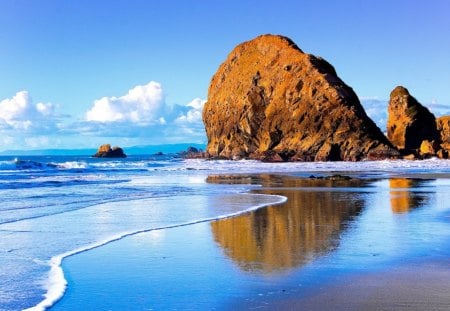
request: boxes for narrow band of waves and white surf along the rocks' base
[5,157,450,177]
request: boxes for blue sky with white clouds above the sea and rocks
[0,0,450,150]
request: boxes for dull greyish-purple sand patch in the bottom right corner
[243,262,450,311]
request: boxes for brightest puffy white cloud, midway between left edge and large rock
[86,81,164,124]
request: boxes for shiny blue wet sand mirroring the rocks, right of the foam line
[52,174,450,310]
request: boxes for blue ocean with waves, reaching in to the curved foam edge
[0,155,450,310]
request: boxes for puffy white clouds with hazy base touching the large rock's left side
[81,81,206,144]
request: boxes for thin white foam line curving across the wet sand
[25,194,287,311]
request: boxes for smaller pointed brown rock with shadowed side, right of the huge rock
[387,86,440,151]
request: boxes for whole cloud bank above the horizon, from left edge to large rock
[0,81,206,150]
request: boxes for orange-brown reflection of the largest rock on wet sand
[211,175,365,273]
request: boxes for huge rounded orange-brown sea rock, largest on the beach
[203,35,397,161]
